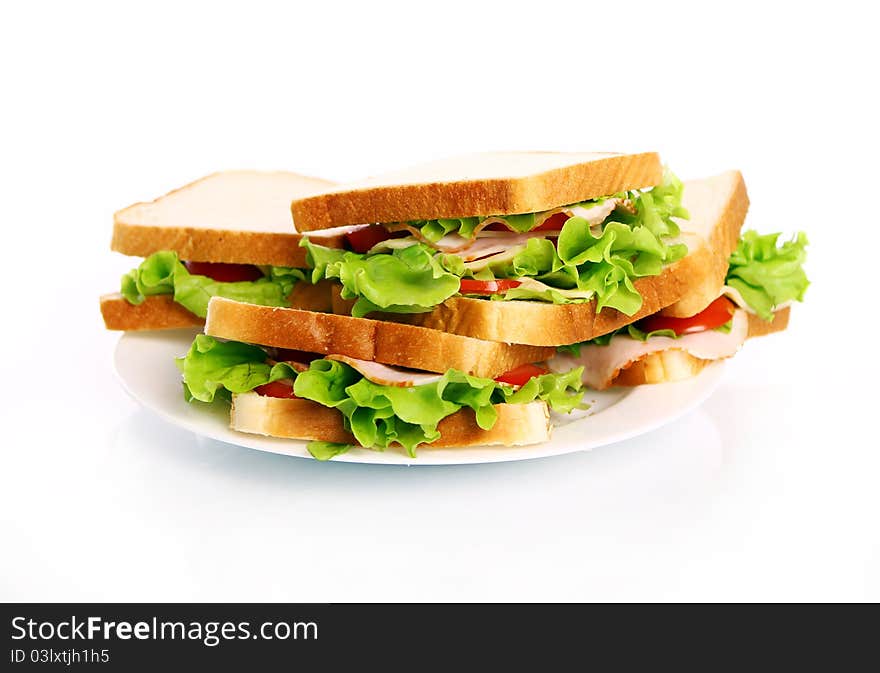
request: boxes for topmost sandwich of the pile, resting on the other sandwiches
[291,153,748,346]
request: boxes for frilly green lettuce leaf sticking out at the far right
[726,231,810,320]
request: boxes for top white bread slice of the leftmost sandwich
[110,171,341,267]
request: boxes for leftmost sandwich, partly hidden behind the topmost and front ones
[101,171,344,330]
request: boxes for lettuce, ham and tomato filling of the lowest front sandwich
[177,334,584,460]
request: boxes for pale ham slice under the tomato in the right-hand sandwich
[547,311,749,390]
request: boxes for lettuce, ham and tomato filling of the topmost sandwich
[301,172,688,317]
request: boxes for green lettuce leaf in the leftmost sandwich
[120,251,305,318]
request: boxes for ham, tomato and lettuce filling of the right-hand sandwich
[548,231,809,390]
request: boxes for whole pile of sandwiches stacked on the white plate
[102,153,807,459]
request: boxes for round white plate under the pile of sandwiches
[115,329,724,465]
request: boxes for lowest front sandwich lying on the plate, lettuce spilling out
[178,297,584,460]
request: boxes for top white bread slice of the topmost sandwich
[290,152,663,231]
